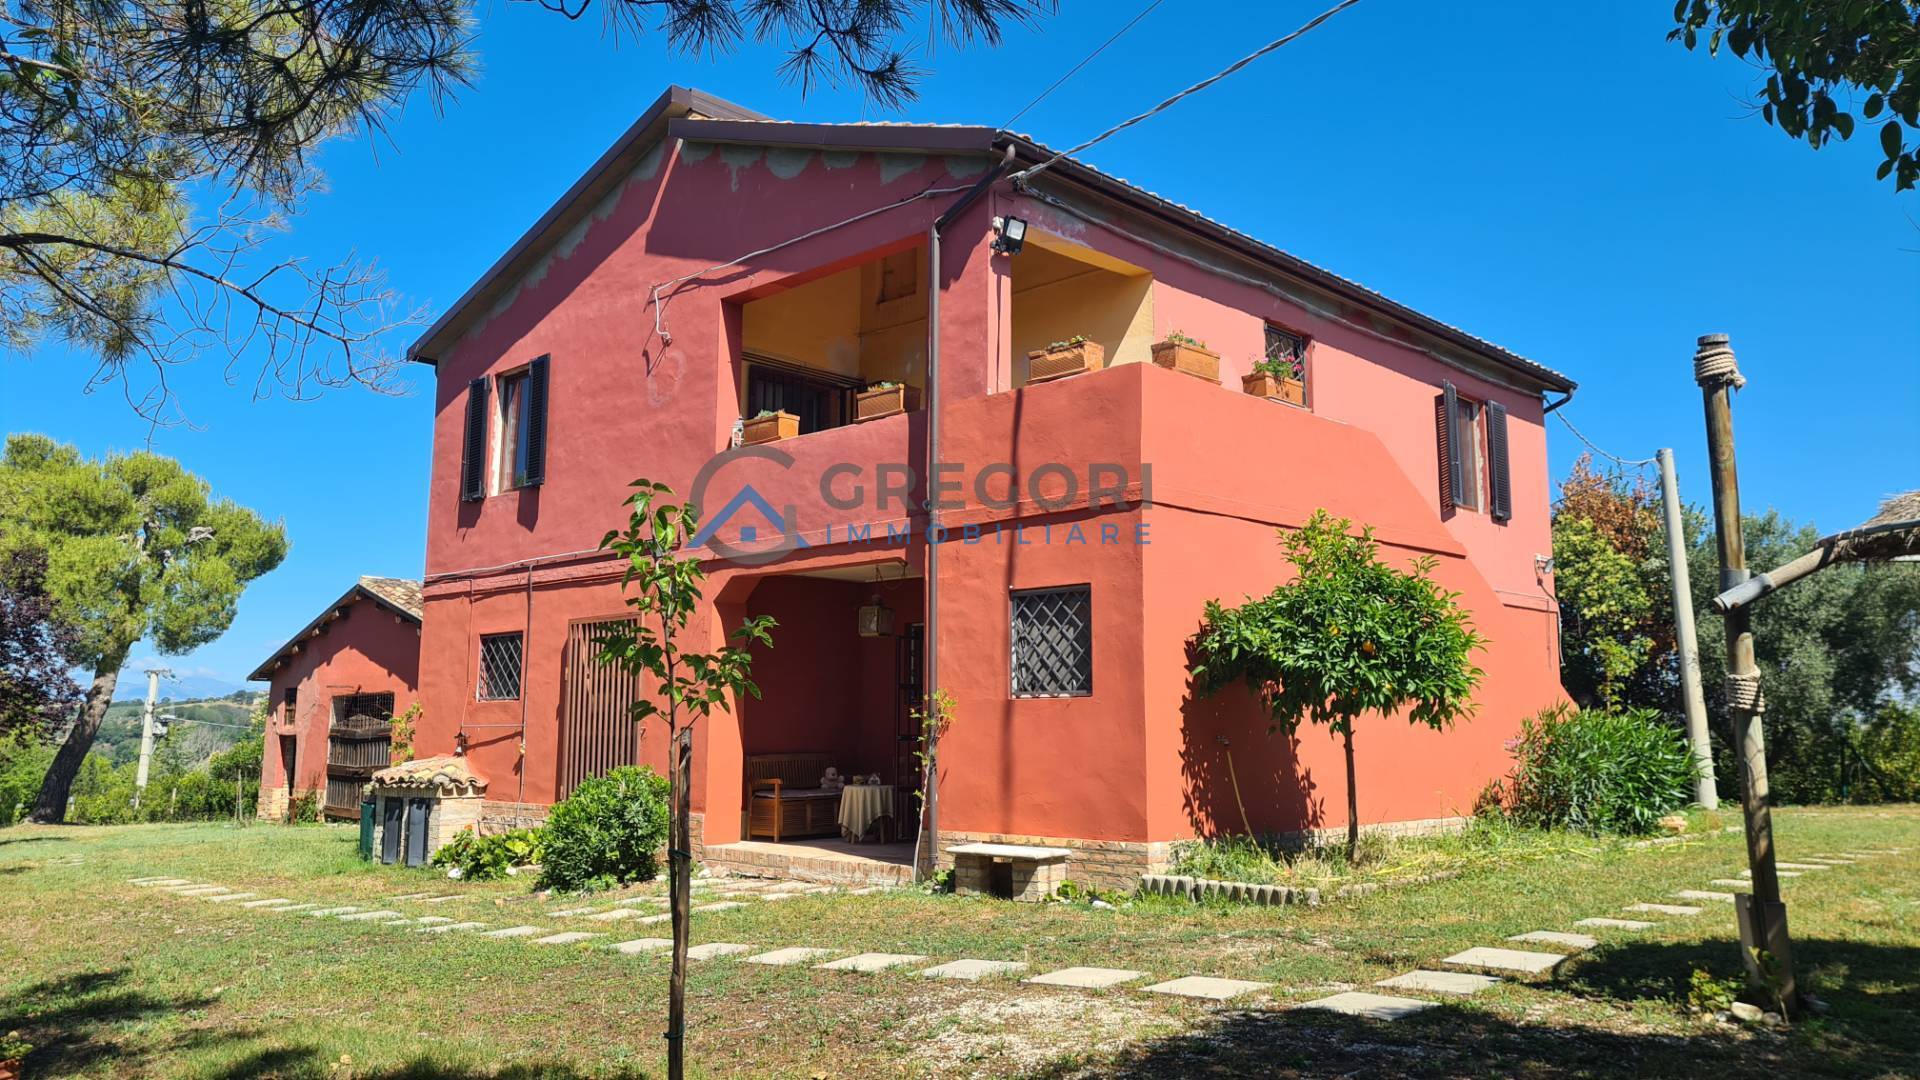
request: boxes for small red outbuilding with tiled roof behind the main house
[248,577,420,821]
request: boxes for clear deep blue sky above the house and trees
[0,0,1920,692]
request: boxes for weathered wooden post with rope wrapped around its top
[1693,334,1799,1017]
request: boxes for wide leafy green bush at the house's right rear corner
[1511,705,1695,836]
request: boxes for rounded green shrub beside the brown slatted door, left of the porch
[540,765,666,892]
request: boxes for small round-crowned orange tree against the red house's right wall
[1194,509,1484,859]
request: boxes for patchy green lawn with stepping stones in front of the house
[0,807,1920,1078]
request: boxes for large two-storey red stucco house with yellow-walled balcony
[393,88,1574,882]
